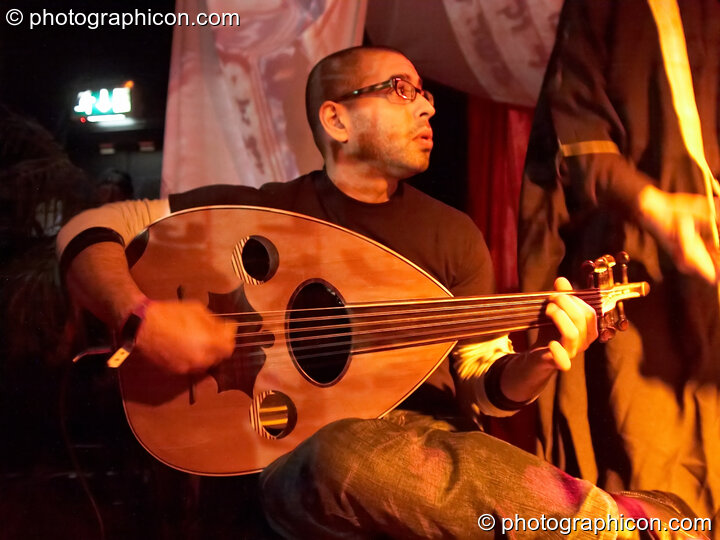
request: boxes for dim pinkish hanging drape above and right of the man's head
[367,0,562,107]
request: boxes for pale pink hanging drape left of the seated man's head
[161,0,366,196]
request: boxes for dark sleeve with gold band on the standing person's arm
[540,0,652,209]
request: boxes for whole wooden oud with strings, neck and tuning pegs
[119,206,649,475]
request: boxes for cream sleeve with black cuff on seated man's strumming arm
[56,199,170,275]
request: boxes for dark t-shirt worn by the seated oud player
[169,171,494,414]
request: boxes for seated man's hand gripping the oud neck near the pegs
[530,277,598,371]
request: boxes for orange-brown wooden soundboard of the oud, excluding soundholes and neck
[119,206,455,475]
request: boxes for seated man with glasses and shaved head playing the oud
[58,48,704,538]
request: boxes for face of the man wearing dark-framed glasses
[343,52,435,179]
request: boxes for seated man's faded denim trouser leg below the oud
[260,410,618,538]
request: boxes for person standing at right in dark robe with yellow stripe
[518,0,720,529]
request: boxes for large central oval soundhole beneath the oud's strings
[287,280,352,386]
